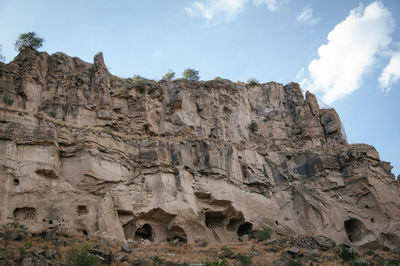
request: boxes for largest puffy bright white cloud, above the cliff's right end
[302,1,394,104]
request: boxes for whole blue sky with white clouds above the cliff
[0,0,400,176]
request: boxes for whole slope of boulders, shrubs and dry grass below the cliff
[0,224,400,266]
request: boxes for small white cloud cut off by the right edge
[378,51,400,92]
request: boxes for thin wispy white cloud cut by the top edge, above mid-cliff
[185,0,278,22]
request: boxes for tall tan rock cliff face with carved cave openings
[0,49,400,247]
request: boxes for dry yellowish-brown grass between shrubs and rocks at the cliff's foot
[0,227,400,265]
